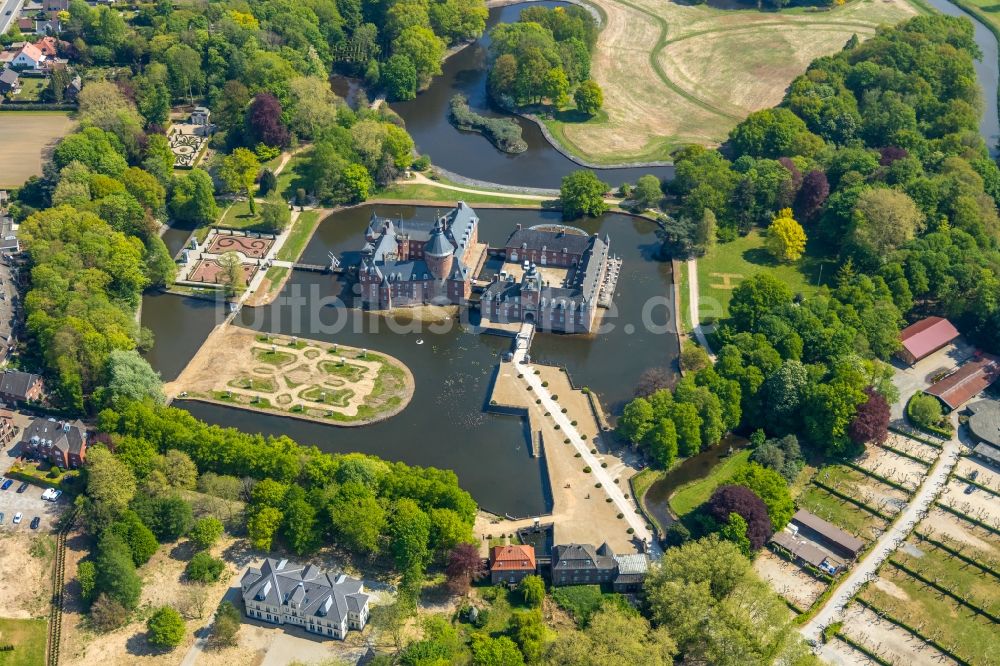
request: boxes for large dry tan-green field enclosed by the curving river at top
[546,0,920,164]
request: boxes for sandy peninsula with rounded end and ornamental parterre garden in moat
[164,323,415,426]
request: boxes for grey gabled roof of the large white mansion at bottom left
[240,557,368,624]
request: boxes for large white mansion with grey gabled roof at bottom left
[240,558,369,640]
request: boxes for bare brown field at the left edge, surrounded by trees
[0,111,73,188]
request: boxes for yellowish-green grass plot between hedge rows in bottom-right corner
[862,566,1000,664]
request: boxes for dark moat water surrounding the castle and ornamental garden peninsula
[142,206,678,516]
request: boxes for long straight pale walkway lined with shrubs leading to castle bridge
[514,324,661,559]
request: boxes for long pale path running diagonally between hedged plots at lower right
[800,439,960,640]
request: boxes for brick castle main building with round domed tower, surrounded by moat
[358,201,486,310]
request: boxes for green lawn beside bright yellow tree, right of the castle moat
[685,229,835,323]
